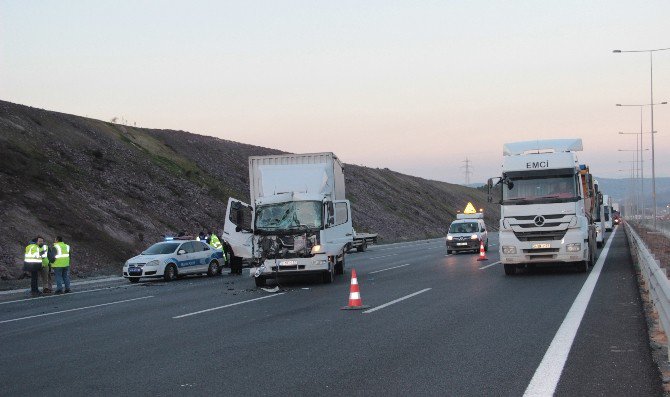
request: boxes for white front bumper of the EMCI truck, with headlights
[500,229,589,264]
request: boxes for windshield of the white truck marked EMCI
[503,175,577,204]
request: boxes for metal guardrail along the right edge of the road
[624,222,670,361]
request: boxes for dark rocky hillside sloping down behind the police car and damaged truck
[0,101,498,280]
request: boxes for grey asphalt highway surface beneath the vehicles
[0,230,662,396]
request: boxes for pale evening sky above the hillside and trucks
[0,0,670,183]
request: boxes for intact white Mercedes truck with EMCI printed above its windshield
[488,139,597,275]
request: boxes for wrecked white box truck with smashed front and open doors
[223,153,354,286]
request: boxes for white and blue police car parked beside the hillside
[123,240,225,283]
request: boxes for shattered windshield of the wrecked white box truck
[256,201,323,231]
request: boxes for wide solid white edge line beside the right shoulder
[523,227,616,396]
